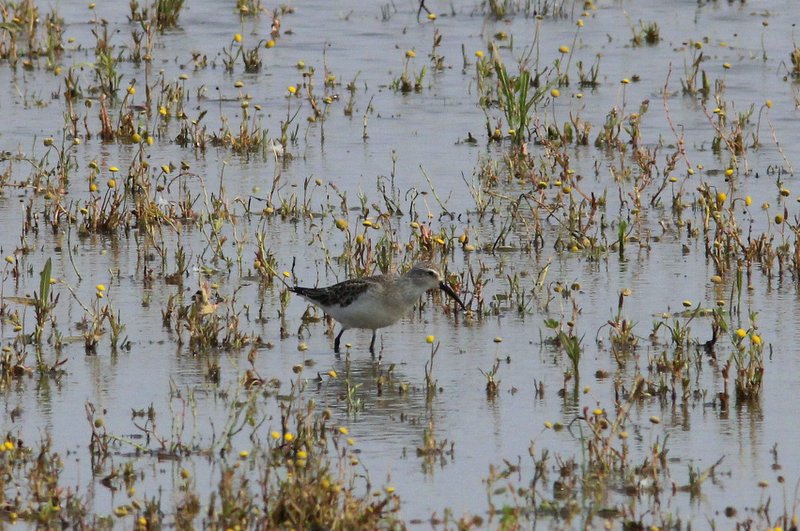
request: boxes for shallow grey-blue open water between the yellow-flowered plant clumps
[0,0,800,527]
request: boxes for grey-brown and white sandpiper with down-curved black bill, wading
[289,262,466,355]
